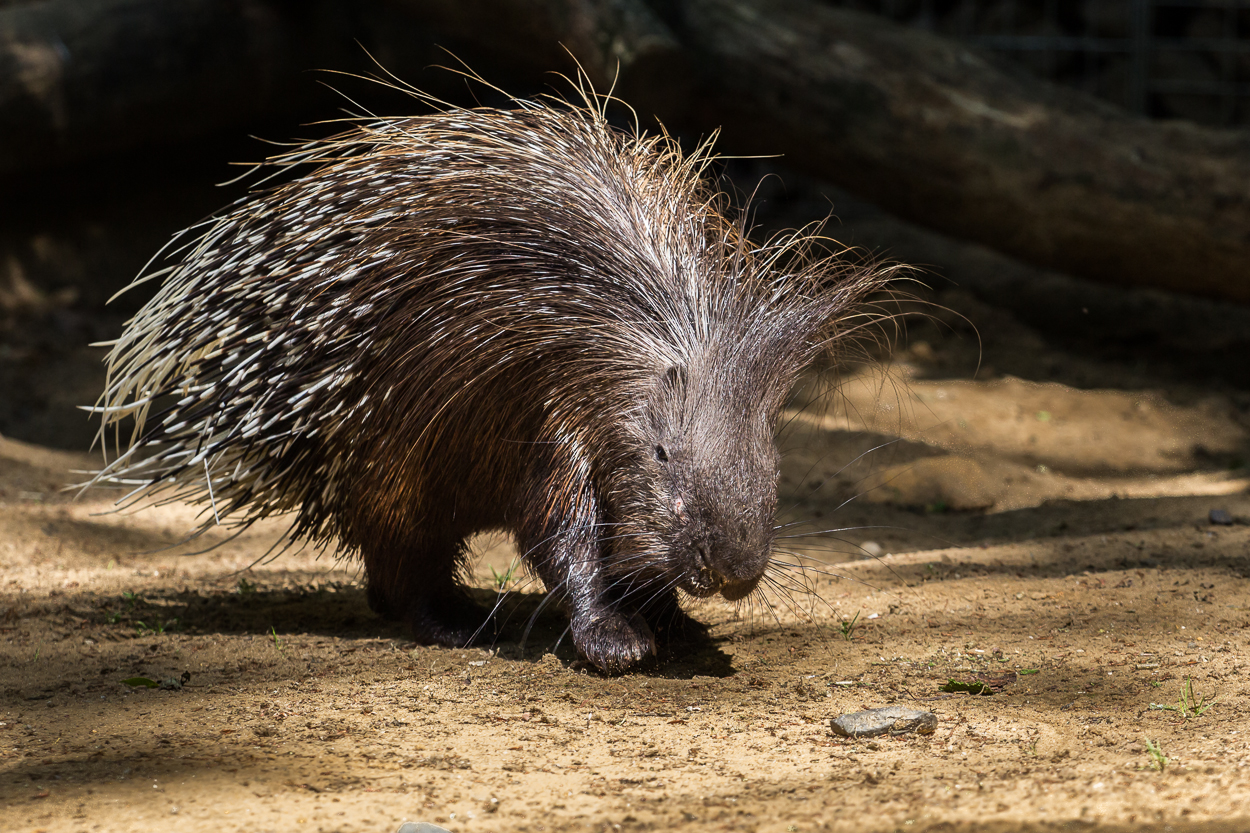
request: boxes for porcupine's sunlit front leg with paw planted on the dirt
[519,488,655,674]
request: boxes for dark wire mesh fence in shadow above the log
[829,0,1250,126]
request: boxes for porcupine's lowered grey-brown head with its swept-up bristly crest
[567,176,885,605]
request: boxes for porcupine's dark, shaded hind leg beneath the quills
[364,537,489,648]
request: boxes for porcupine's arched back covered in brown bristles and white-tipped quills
[98,93,840,548]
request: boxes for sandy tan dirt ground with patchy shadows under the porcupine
[0,185,1250,833]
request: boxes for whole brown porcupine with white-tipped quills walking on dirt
[95,79,885,673]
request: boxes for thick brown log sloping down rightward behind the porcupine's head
[668,0,1250,303]
